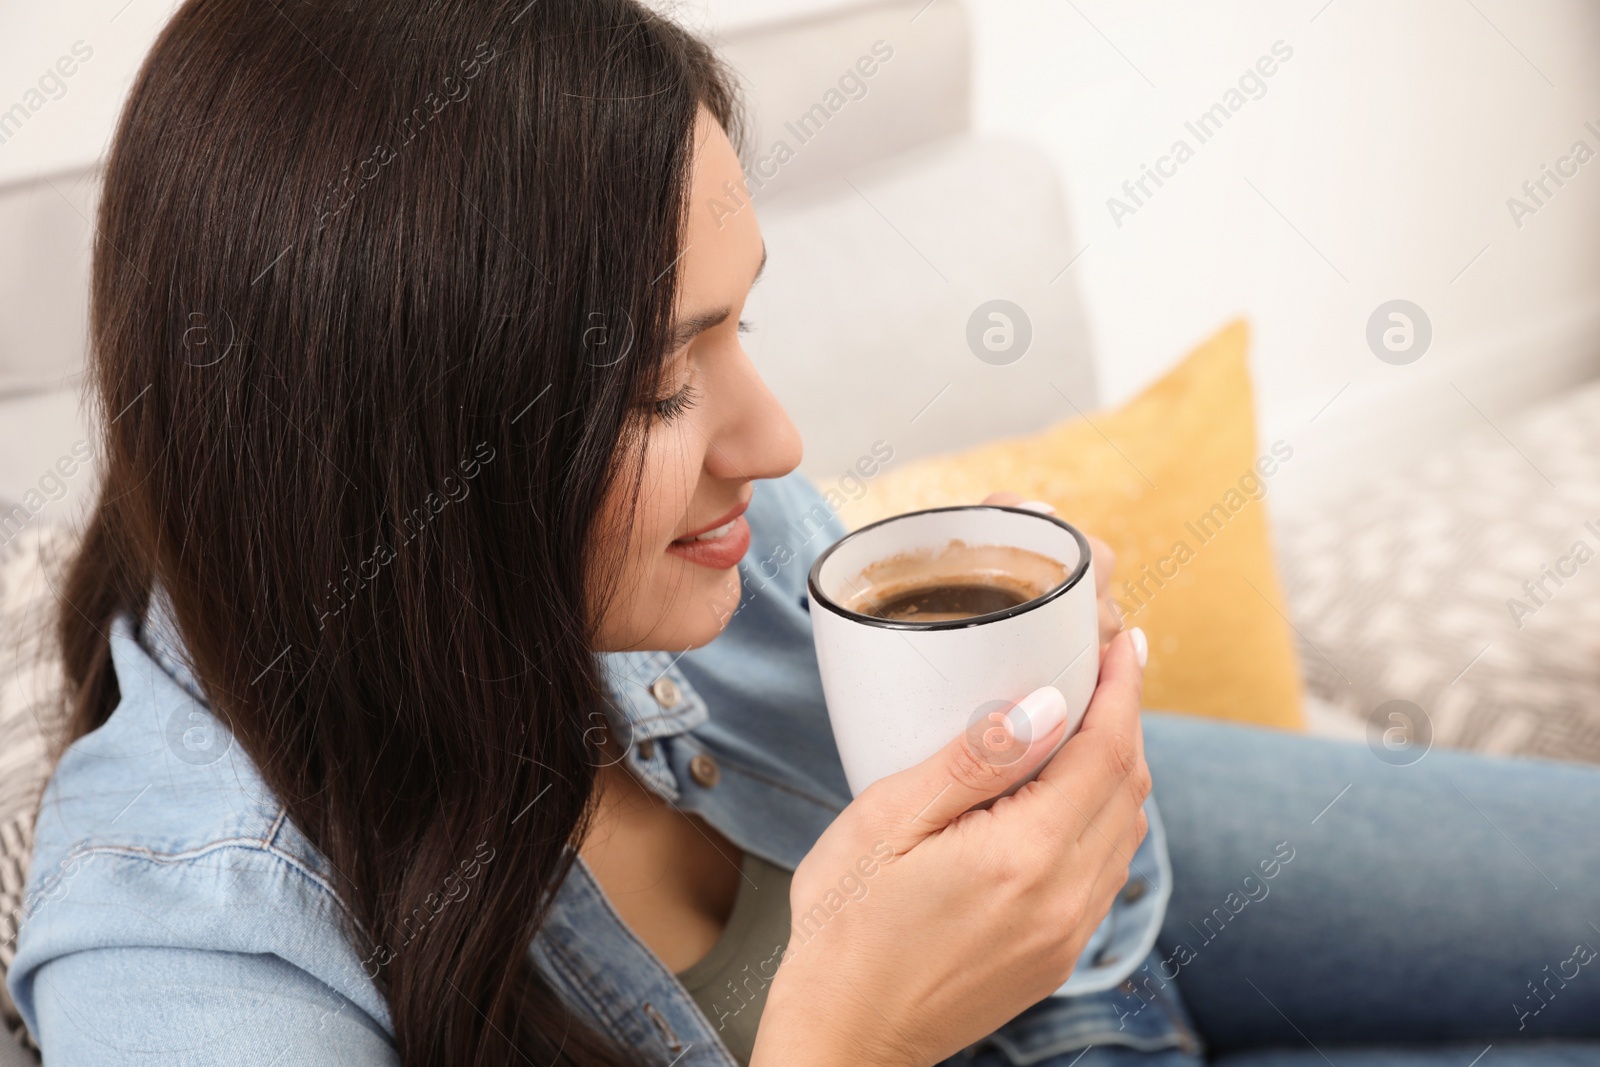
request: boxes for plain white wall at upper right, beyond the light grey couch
[973,0,1600,495]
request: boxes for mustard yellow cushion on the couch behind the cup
[840,322,1304,729]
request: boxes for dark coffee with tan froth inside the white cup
[840,541,1070,622]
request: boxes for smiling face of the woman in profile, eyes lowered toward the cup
[597,107,800,651]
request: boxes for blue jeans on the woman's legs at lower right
[971,712,1600,1067]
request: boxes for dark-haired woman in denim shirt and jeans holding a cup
[10,0,1600,1067]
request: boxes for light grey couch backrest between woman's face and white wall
[716,0,1098,490]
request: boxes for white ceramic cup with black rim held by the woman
[806,504,1099,795]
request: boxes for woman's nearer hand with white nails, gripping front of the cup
[750,632,1150,1067]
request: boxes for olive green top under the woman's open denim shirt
[678,853,790,1067]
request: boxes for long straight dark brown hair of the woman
[59,0,739,1067]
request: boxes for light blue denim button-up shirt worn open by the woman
[10,475,1192,1067]
